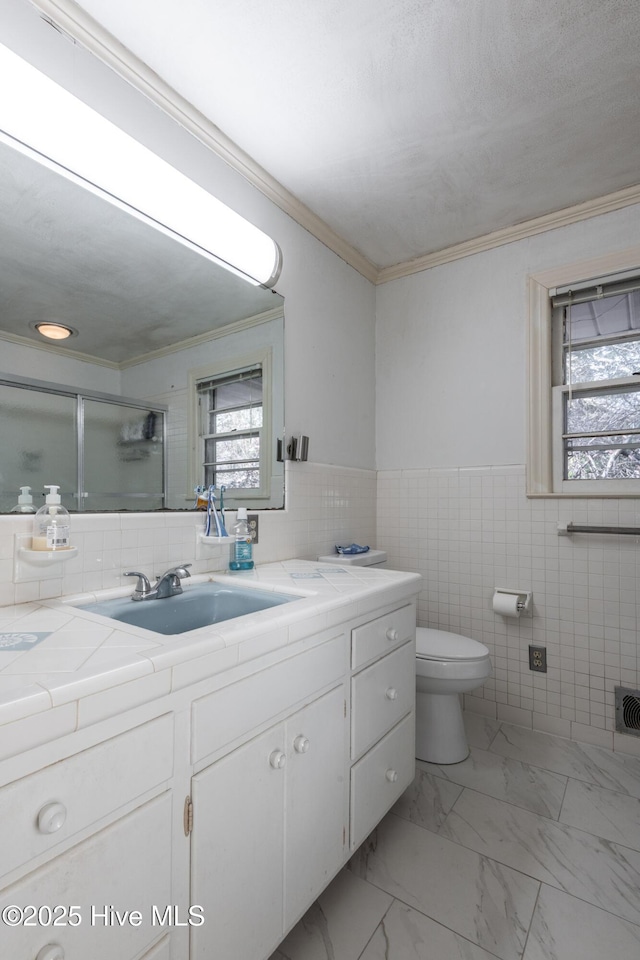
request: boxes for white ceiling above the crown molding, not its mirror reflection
[47,0,640,267]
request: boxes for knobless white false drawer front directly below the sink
[191,633,347,763]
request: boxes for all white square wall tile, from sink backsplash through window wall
[6,463,640,753]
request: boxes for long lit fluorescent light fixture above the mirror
[0,44,282,287]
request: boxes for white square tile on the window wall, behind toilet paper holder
[377,465,640,752]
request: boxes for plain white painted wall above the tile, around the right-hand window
[376,206,640,470]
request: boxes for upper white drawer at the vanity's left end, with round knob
[0,714,173,876]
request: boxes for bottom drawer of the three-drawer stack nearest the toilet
[351,713,416,850]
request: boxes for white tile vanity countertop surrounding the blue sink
[0,560,421,759]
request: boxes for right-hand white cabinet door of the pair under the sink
[285,686,348,930]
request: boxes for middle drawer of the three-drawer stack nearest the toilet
[351,642,416,760]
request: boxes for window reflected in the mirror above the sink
[190,352,271,503]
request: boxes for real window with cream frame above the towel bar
[528,255,640,497]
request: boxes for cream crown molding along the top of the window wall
[376,185,640,283]
